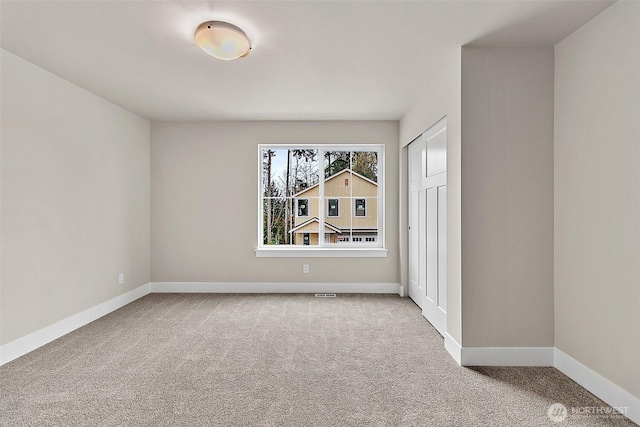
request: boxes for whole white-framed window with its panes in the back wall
[256,145,386,256]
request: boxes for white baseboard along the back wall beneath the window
[150,282,401,295]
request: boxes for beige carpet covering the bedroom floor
[0,294,635,427]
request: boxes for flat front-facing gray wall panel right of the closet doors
[462,47,554,347]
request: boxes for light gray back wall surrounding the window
[151,121,399,289]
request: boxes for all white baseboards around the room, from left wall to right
[0,282,640,424]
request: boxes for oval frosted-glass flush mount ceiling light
[193,21,251,61]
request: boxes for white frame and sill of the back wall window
[255,144,387,258]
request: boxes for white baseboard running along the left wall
[0,283,150,366]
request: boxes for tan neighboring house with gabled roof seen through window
[290,169,378,245]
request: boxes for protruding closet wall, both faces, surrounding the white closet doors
[399,47,553,347]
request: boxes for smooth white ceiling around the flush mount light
[0,0,611,120]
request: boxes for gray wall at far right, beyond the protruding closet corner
[555,2,640,397]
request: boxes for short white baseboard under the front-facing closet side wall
[460,347,553,366]
